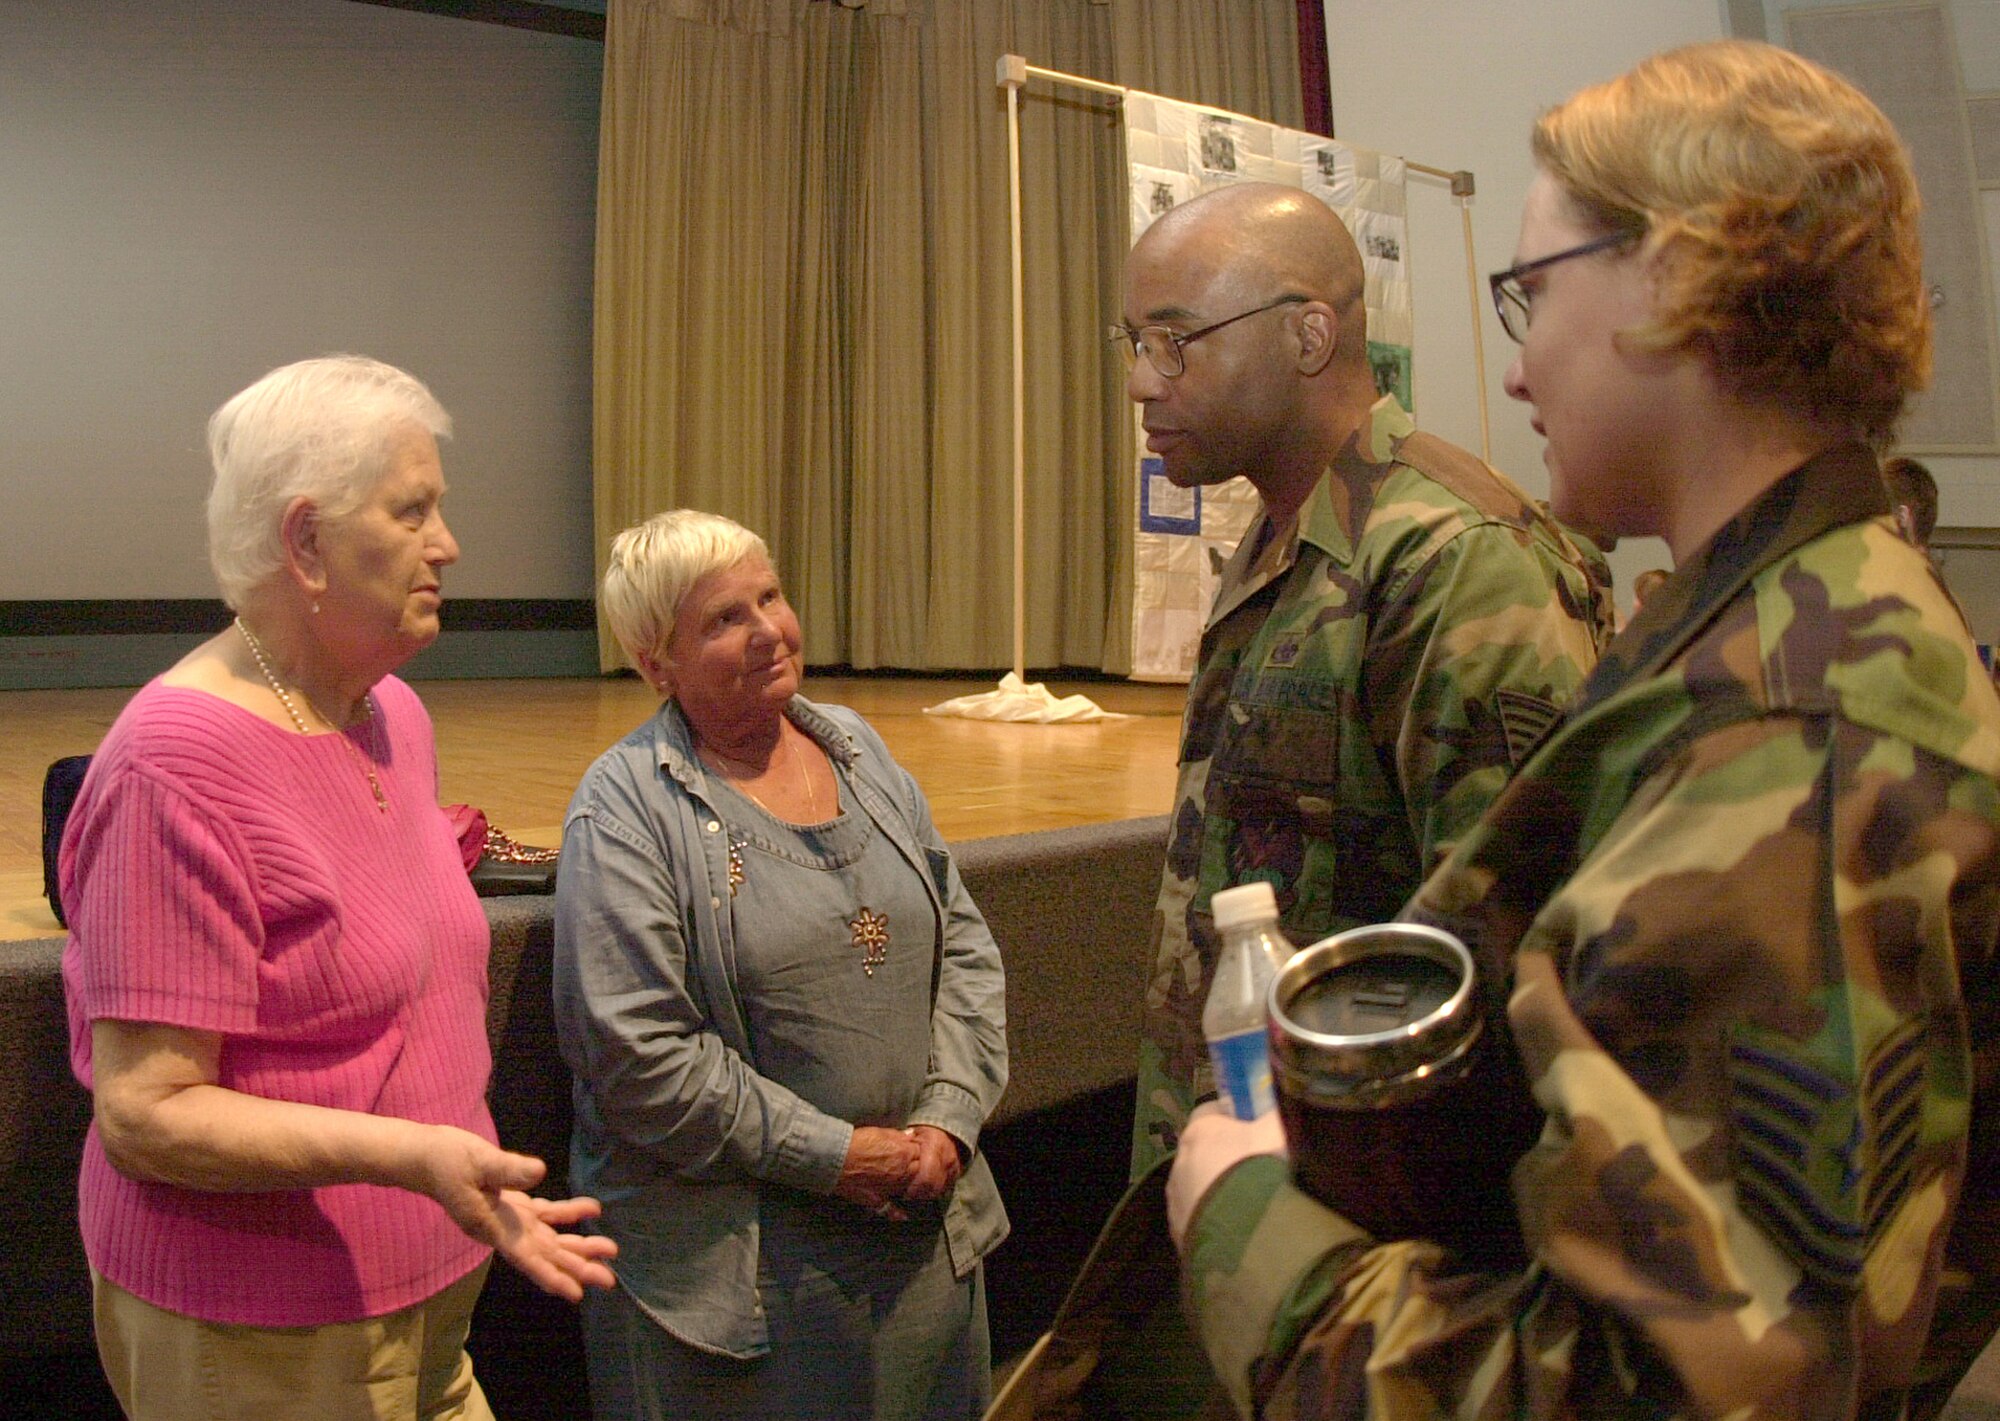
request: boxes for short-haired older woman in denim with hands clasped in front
[556,510,1006,1421]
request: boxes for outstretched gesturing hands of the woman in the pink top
[420,1125,618,1303]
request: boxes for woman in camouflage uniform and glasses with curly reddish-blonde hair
[1170,42,2000,1417]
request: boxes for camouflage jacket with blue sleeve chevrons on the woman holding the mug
[1186,446,2000,1419]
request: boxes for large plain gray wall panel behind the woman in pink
[0,0,604,600]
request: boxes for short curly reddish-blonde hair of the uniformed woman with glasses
[1532,40,1930,446]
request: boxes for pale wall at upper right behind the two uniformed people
[1326,0,2000,624]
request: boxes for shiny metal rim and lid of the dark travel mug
[1266,923,1480,1095]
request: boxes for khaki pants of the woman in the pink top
[90,1263,494,1421]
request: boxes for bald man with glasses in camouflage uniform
[1120,184,1598,1177]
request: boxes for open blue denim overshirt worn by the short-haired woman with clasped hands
[554,696,1008,1357]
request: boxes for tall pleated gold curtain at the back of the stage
[594,0,1300,670]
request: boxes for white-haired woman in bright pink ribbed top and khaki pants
[62,356,616,1421]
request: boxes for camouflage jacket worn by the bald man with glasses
[1132,398,1598,1179]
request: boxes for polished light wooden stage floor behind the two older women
[0,676,1186,941]
